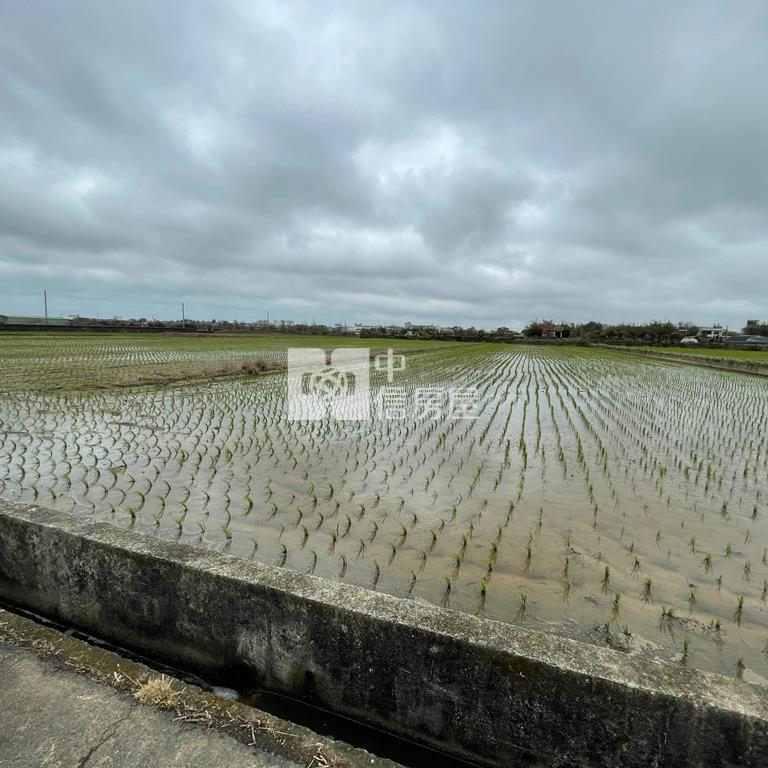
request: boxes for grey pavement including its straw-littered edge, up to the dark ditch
[0,609,403,768]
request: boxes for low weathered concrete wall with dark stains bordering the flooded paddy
[0,501,768,768]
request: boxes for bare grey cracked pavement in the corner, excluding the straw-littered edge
[0,644,295,768]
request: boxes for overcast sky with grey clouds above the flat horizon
[0,0,768,328]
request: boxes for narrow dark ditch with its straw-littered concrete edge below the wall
[0,601,477,768]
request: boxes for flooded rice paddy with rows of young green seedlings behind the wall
[0,335,768,682]
